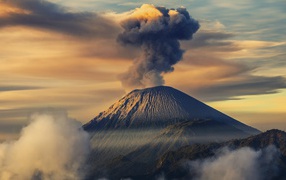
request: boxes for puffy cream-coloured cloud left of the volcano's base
[0,114,90,180]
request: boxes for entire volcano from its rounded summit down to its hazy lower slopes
[83,86,260,179]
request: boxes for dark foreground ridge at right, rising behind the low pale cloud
[156,130,286,180]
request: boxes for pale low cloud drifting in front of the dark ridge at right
[189,146,280,180]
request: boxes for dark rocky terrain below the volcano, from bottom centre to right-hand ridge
[87,130,286,180]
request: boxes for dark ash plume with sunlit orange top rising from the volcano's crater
[117,4,199,89]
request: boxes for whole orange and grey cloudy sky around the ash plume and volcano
[0,0,286,140]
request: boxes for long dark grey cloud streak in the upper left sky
[0,0,119,38]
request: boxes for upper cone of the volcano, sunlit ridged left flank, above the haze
[83,86,259,134]
